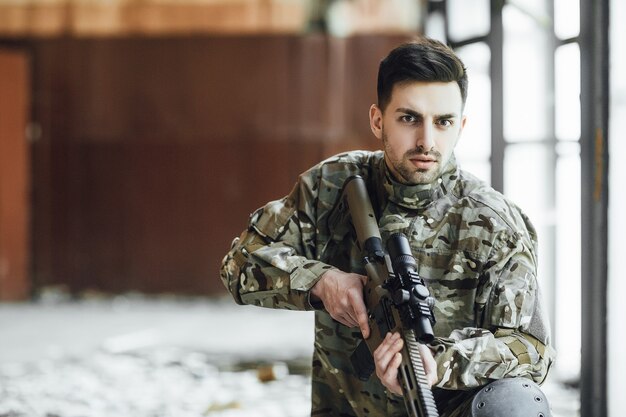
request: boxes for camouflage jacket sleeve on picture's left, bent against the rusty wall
[220,169,332,310]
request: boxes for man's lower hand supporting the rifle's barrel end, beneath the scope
[374,333,438,395]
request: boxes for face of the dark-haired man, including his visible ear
[370,82,466,184]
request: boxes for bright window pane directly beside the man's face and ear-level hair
[456,43,491,182]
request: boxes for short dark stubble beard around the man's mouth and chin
[382,131,441,185]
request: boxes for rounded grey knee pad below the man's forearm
[471,378,552,417]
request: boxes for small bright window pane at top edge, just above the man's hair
[446,0,490,41]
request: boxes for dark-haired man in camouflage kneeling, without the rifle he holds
[221,39,554,417]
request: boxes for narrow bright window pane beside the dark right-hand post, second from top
[555,43,580,140]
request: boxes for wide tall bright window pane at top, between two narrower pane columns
[503,6,552,141]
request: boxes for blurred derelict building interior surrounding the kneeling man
[0,0,626,417]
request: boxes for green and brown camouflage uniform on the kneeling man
[220,151,554,416]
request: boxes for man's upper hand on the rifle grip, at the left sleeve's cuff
[311,269,370,339]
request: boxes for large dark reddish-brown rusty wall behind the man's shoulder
[29,36,408,294]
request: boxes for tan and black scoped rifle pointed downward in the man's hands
[344,176,439,417]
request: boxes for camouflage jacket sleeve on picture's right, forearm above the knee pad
[433,223,555,389]
